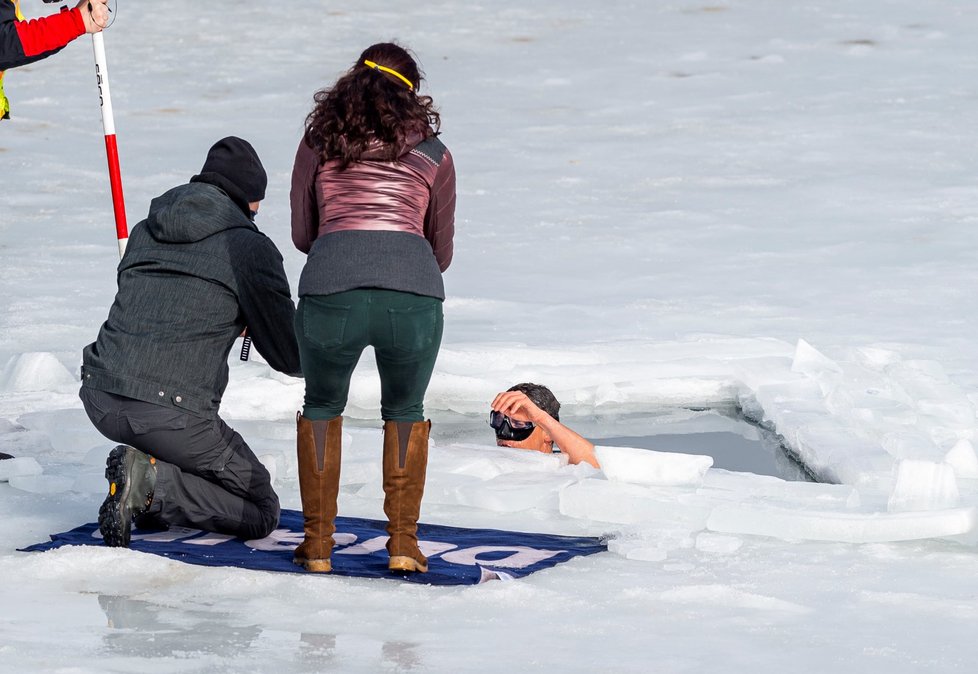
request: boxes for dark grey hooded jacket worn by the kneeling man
[82,181,301,417]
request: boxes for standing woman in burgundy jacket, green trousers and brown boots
[291,43,455,572]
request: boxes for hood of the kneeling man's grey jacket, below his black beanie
[146,182,257,243]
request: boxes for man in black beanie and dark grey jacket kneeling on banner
[80,136,301,546]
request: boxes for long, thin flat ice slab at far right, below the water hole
[706,504,978,543]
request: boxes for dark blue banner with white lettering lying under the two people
[24,510,607,585]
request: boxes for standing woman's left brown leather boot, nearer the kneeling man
[292,413,343,573]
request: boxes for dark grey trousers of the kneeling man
[79,386,279,539]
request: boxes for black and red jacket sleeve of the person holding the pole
[0,0,85,70]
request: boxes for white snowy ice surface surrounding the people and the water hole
[0,0,978,673]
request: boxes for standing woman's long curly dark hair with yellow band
[306,42,441,170]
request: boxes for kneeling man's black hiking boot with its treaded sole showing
[98,445,156,548]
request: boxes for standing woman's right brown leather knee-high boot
[384,421,431,573]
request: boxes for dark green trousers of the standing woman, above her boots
[295,288,445,421]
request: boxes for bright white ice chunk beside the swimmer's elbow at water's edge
[594,445,713,485]
